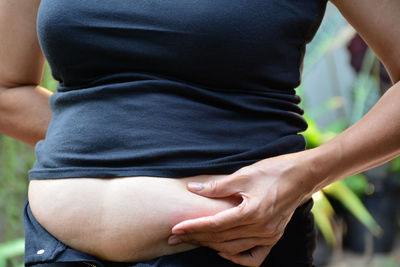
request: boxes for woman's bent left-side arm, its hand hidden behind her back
[0,0,51,146]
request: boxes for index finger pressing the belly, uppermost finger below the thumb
[172,198,248,234]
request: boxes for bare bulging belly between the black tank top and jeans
[28,175,240,262]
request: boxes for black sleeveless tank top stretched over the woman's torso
[30,0,326,179]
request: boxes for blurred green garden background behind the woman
[0,4,400,267]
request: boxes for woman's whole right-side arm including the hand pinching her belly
[172,0,400,266]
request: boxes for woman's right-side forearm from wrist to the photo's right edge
[299,82,400,196]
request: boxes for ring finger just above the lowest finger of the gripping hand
[196,237,275,255]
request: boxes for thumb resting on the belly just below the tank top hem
[187,175,242,198]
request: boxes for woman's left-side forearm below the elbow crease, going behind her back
[0,85,52,146]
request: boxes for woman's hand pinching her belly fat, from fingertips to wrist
[169,153,314,266]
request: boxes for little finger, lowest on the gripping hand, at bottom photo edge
[218,246,271,267]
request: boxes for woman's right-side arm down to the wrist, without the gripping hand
[296,0,400,197]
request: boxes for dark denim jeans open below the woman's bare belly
[23,200,316,267]
